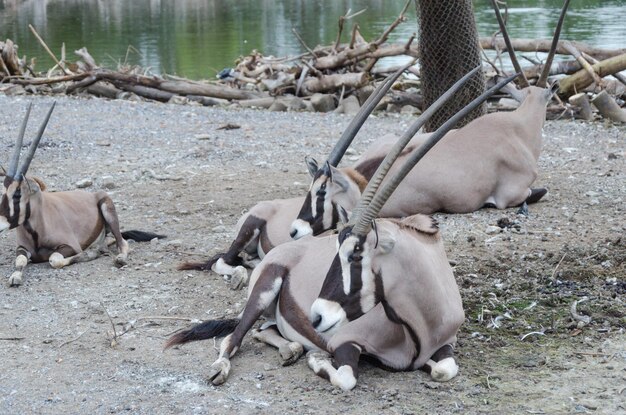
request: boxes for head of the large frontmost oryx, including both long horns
[310,67,517,335]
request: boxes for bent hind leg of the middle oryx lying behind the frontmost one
[211,215,266,290]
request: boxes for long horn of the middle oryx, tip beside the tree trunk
[328,61,415,167]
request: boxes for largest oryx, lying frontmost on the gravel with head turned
[165,72,512,389]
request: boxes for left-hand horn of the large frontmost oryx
[349,66,481,225]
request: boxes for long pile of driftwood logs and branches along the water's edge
[0,10,626,122]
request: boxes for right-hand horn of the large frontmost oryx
[352,74,519,235]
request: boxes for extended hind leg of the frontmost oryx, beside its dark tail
[208,264,288,385]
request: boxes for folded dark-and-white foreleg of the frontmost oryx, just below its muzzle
[307,343,361,390]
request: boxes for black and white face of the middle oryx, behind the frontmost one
[290,163,339,239]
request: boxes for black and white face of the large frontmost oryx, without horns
[310,228,383,334]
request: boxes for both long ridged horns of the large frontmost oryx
[348,70,519,236]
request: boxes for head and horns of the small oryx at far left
[0,104,55,232]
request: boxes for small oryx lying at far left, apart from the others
[0,104,163,286]
